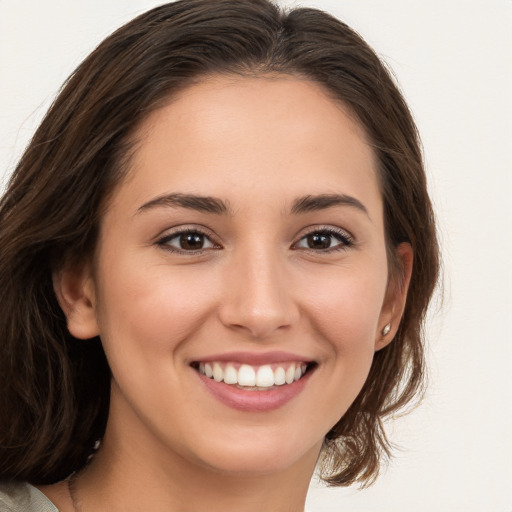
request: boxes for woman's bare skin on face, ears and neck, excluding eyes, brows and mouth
[41,76,412,512]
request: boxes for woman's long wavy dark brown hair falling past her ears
[0,0,438,485]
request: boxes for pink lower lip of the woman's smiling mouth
[194,370,313,412]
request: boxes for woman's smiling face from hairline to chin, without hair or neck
[63,77,408,474]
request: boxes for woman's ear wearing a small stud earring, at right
[375,242,414,350]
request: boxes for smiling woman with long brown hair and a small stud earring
[0,0,438,512]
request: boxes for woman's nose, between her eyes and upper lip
[219,245,299,339]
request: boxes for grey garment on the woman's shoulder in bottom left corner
[0,482,59,512]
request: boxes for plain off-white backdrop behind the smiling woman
[0,0,512,512]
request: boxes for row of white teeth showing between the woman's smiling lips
[192,361,315,391]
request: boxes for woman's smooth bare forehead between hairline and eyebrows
[114,76,380,218]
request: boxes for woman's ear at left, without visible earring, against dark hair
[53,265,99,340]
